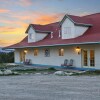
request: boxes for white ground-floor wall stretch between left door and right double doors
[14,47,81,67]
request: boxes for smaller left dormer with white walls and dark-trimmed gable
[26,24,51,43]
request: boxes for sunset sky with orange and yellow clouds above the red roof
[0,0,100,47]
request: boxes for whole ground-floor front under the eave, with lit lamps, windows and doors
[15,44,100,68]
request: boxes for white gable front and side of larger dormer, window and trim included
[60,16,90,39]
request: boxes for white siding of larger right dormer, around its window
[62,18,88,39]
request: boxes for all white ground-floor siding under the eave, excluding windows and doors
[15,45,100,69]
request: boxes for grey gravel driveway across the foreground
[0,75,100,100]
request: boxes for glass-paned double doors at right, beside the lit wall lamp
[82,50,95,67]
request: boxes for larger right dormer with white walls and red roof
[60,15,92,39]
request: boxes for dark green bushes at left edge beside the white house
[0,52,14,63]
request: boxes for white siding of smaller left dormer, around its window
[28,27,47,43]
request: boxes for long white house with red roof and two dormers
[6,13,100,69]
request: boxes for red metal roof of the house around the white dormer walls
[7,13,100,48]
